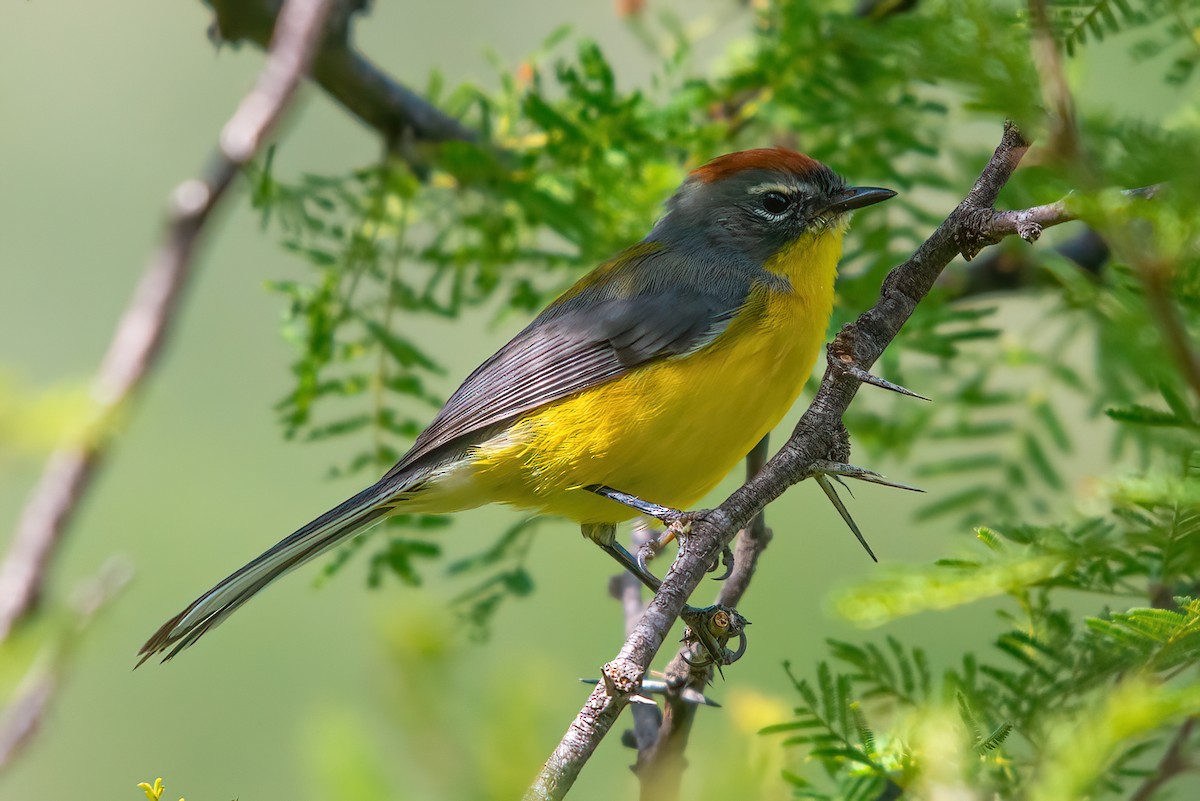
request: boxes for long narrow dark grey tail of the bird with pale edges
[138,481,396,666]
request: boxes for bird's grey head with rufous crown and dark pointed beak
[648,147,895,261]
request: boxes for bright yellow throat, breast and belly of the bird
[451,231,841,523]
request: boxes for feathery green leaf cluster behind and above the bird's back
[251,0,1060,609]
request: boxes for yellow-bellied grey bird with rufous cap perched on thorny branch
[138,147,895,664]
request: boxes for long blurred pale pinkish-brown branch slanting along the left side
[0,0,330,642]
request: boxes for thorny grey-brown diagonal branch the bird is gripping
[526,124,1099,799]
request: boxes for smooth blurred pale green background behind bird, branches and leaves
[0,0,1180,801]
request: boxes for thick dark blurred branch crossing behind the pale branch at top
[205,0,478,150]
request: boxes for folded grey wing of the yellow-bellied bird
[385,246,752,480]
